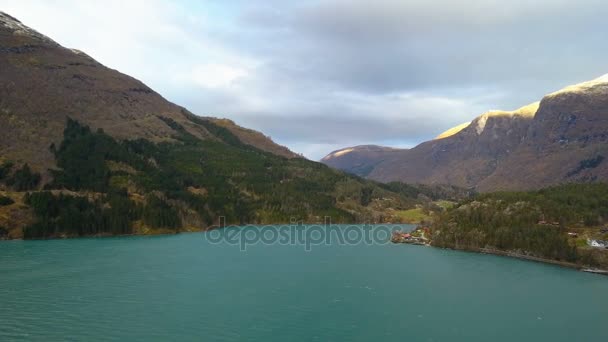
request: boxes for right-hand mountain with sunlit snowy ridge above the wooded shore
[324,76,608,192]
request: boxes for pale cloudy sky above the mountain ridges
[0,0,608,159]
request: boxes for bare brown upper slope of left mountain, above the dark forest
[0,12,295,173]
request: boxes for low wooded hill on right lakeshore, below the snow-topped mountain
[432,184,608,264]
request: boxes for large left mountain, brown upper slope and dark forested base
[0,12,426,238]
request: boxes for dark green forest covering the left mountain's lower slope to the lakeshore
[19,117,434,238]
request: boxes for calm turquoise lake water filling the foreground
[0,223,608,341]
